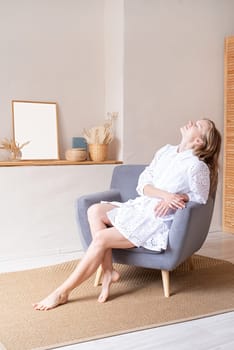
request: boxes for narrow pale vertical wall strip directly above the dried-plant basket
[104,0,124,160]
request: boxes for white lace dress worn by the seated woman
[107,145,210,251]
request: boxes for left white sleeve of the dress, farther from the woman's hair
[136,145,168,196]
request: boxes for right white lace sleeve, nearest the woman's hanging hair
[187,161,210,204]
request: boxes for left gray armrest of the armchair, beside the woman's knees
[76,190,122,250]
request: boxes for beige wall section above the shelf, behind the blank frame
[0,0,105,156]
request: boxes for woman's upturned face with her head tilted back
[180,119,210,142]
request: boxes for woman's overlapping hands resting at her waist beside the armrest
[154,193,188,216]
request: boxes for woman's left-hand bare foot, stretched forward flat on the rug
[33,290,68,311]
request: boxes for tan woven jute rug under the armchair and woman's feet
[0,255,234,350]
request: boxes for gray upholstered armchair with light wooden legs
[76,165,215,297]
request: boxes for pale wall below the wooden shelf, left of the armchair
[0,165,114,265]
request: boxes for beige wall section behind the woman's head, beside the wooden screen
[123,0,234,162]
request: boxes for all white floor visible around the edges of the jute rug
[0,232,234,350]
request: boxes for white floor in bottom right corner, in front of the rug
[62,312,234,350]
